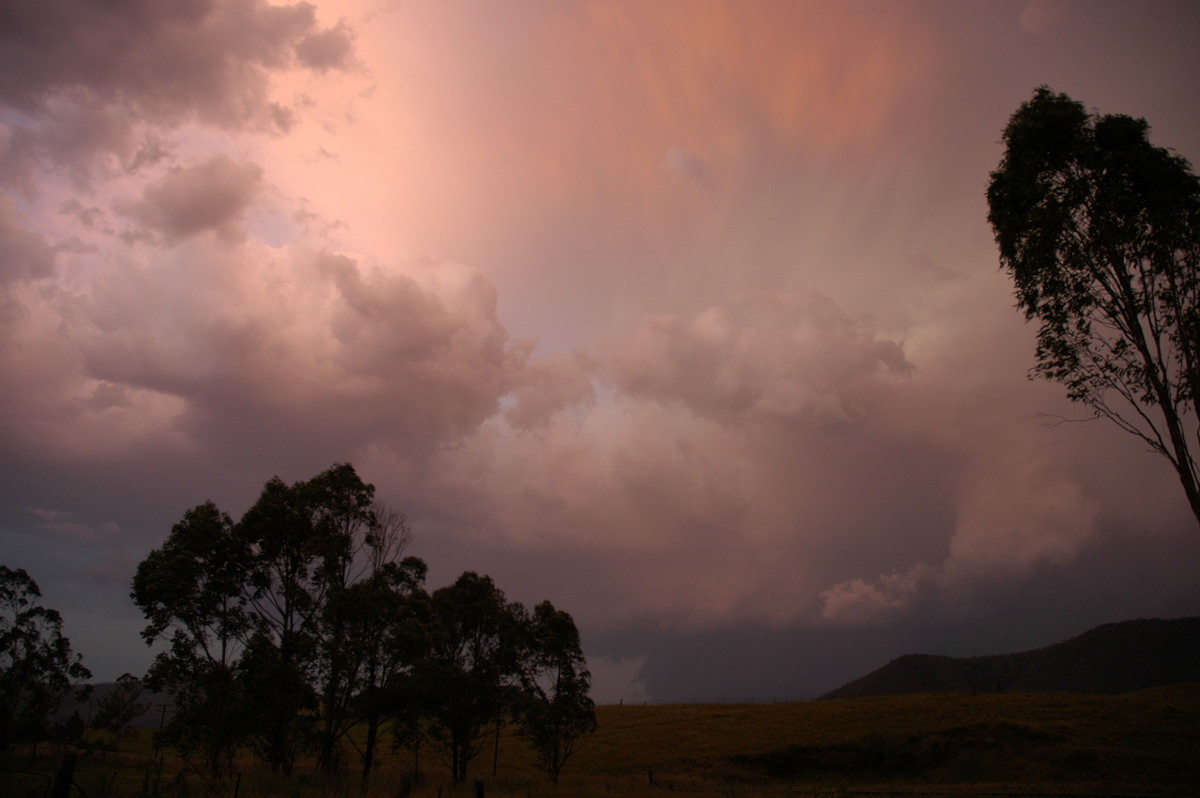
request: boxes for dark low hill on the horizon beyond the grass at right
[822,618,1200,698]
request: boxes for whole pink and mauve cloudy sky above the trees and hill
[0,0,1200,701]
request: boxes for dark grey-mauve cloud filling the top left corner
[0,0,354,196]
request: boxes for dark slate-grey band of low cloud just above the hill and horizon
[584,516,1200,702]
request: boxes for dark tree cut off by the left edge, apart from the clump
[0,565,91,748]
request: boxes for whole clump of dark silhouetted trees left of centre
[132,463,595,781]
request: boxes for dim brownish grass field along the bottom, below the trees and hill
[0,685,1200,798]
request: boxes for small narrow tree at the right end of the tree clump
[516,601,596,784]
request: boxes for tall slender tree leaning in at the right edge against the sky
[988,86,1200,522]
